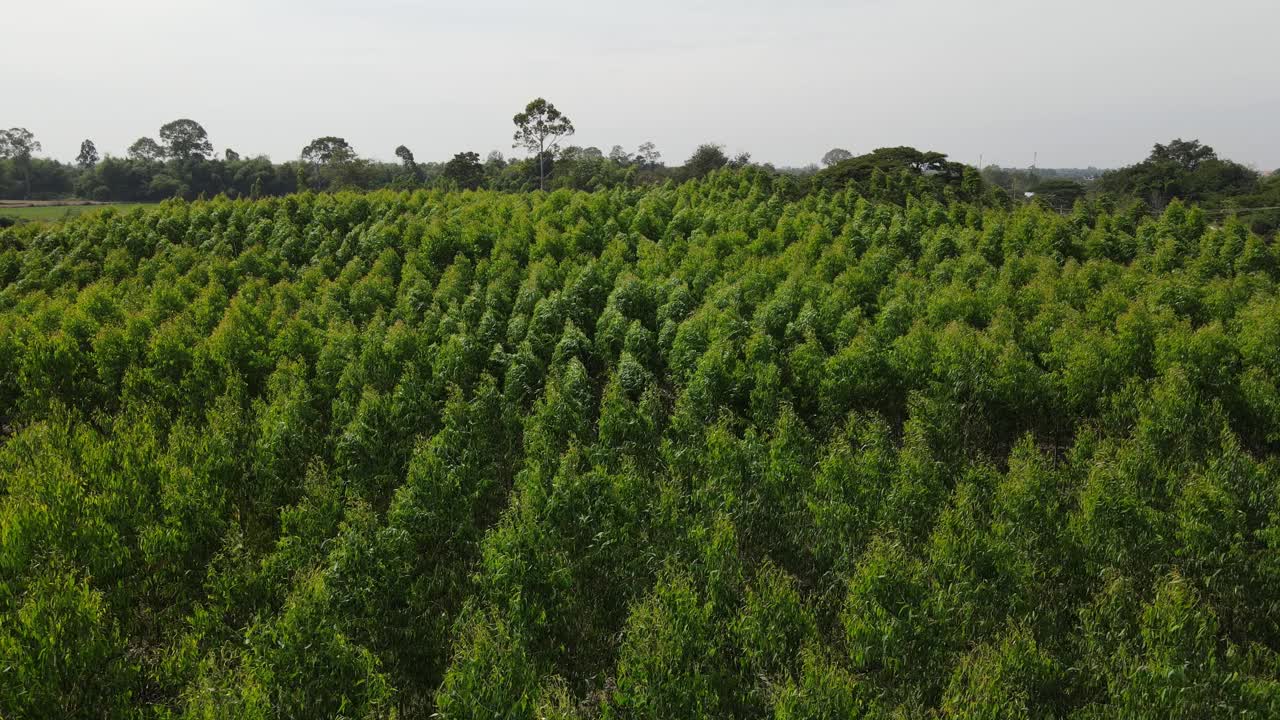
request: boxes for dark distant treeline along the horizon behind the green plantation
[0,114,1280,233]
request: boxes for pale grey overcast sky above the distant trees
[10,0,1280,170]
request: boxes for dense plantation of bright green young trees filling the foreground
[0,164,1280,720]
